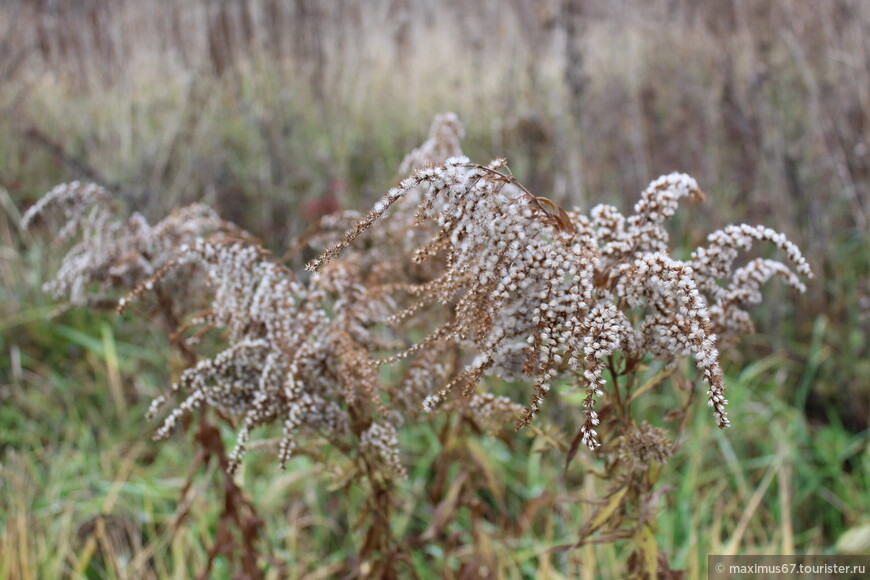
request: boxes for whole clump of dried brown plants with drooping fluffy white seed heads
[27,114,812,576]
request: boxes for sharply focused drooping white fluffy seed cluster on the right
[308,122,812,449]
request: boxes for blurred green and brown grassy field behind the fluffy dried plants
[0,0,870,578]
